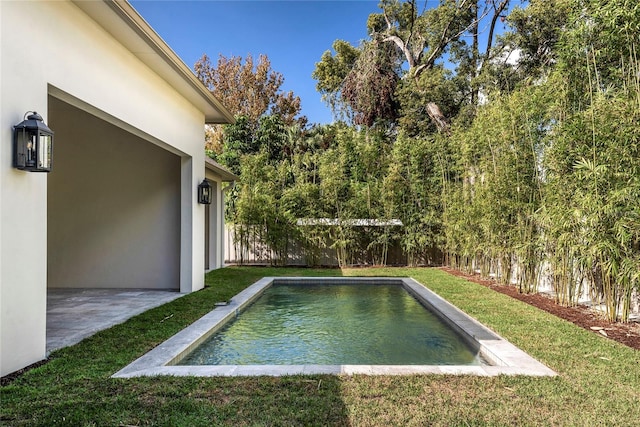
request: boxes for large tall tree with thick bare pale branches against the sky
[314,0,509,132]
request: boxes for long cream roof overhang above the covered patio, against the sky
[71,0,234,124]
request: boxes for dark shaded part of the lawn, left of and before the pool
[0,267,348,426]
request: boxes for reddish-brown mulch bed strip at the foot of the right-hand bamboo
[441,267,640,350]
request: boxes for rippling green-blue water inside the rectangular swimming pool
[178,284,482,365]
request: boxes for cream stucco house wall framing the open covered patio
[0,1,215,375]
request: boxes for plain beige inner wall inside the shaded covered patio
[47,97,180,290]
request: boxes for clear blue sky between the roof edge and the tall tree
[131,0,380,123]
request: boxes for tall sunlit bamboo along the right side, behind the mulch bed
[443,1,640,321]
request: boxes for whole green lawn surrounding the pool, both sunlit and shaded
[0,267,640,426]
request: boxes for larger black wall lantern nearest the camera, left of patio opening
[13,111,53,172]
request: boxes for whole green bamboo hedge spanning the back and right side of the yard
[218,0,640,321]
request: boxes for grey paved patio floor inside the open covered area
[47,288,184,355]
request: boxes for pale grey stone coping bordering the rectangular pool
[112,277,557,378]
